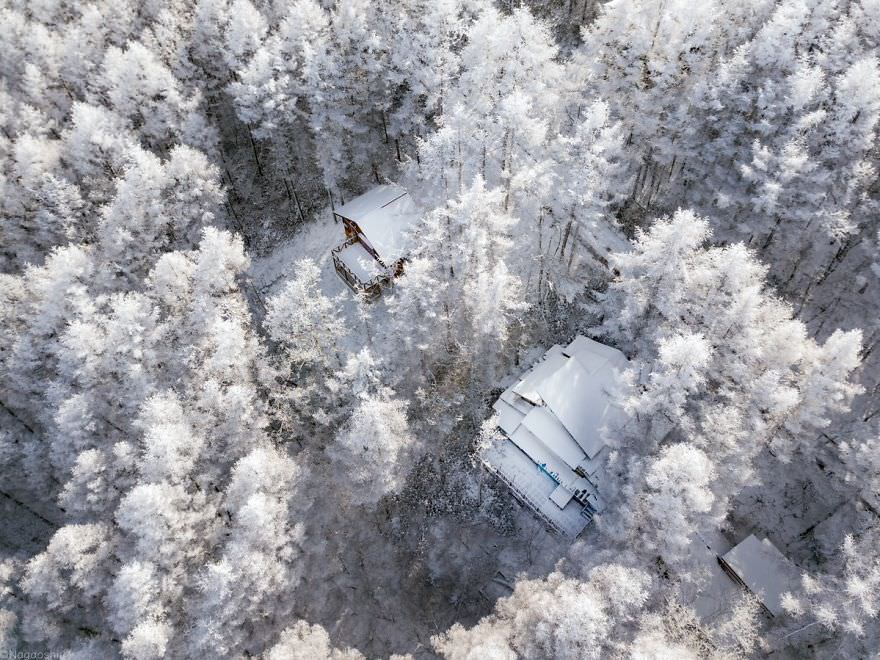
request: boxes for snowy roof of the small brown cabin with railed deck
[335,183,419,266]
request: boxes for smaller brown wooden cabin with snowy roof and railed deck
[331,183,419,297]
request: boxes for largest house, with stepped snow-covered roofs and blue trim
[480,336,628,538]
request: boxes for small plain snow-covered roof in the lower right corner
[721,534,800,616]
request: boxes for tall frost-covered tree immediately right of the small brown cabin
[391,177,527,390]
